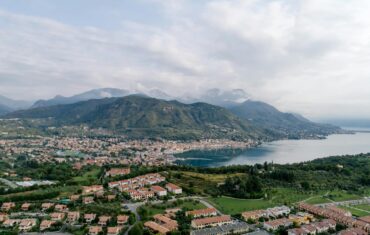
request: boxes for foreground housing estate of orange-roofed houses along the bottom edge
[0,157,370,235]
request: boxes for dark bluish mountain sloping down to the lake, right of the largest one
[229,100,340,138]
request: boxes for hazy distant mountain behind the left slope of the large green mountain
[31,88,130,108]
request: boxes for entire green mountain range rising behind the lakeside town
[5,90,338,139]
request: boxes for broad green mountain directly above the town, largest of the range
[5,95,268,139]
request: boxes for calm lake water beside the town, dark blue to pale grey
[178,133,370,167]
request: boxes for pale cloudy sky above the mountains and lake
[0,0,370,118]
